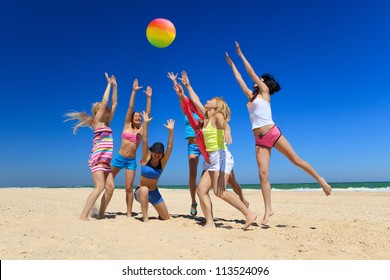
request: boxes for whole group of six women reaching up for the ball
[66,42,332,229]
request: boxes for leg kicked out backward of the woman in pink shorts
[275,135,332,196]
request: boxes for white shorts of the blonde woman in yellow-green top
[202,149,234,174]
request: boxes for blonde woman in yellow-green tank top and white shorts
[178,71,256,229]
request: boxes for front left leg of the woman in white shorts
[196,171,215,227]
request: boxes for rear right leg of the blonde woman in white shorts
[213,171,257,229]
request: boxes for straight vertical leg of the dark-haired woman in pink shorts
[256,146,274,225]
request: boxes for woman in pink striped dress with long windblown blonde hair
[65,73,118,221]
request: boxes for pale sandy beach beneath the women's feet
[0,188,390,260]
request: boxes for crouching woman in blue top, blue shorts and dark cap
[134,112,175,222]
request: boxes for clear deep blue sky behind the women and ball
[0,0,390,187]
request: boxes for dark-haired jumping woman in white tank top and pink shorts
[226,42,332,224]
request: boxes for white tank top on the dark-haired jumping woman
[248,98,274,130]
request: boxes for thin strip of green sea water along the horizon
[5,182,390,192]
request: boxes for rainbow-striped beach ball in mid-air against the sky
[146,18,176,48]
